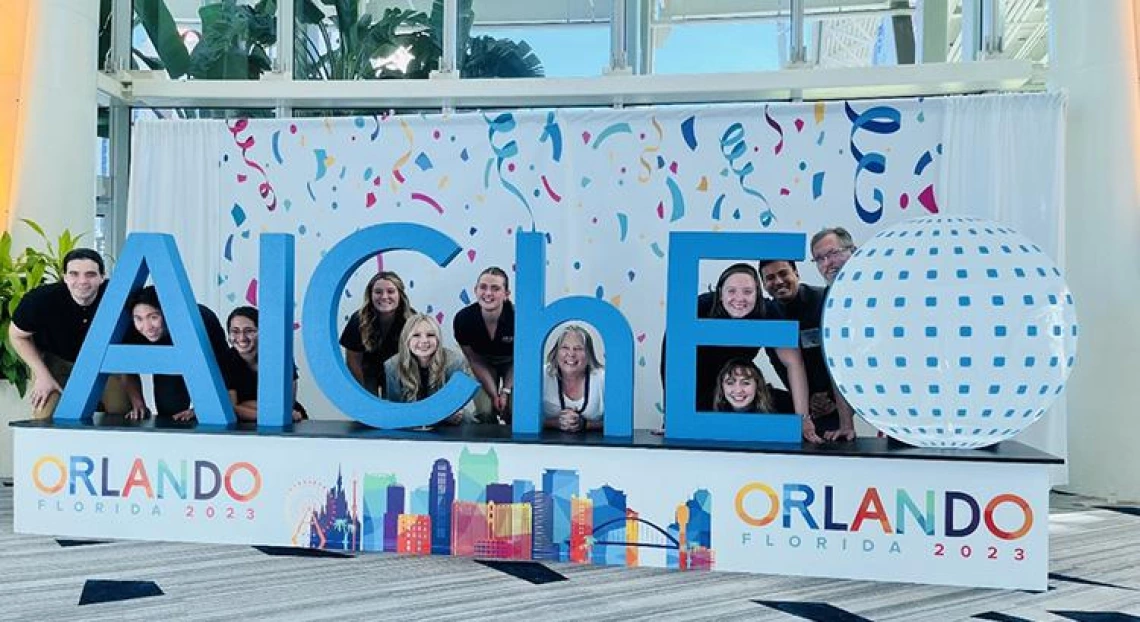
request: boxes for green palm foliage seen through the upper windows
[99,0,543,80]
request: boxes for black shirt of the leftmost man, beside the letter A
[11,281,107,362]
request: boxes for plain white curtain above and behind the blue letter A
[127,121,226,309]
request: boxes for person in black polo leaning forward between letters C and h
[451,265,514,423]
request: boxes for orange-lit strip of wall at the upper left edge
[0,0,30,227]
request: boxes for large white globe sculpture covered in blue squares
[823,216,1077,448]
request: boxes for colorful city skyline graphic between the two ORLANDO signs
[290,447,715,570]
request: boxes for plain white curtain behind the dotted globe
[939,93,1062,484]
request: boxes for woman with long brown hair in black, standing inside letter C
[341,271,415,396]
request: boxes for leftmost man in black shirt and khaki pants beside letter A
[8,248,146,419]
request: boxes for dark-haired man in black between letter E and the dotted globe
[759,260,855,441]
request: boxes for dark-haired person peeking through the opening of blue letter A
[125,286,236,422]
